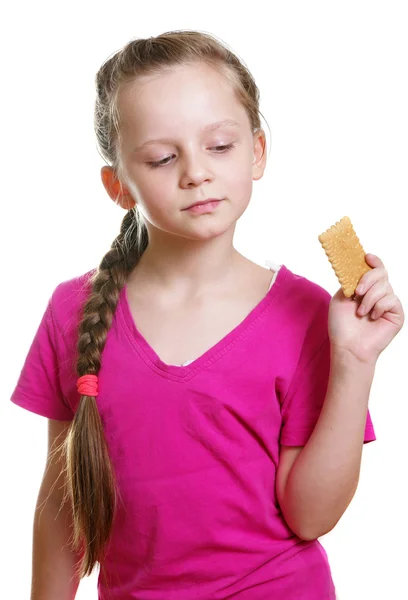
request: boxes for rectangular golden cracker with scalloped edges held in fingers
[319,217,372,298]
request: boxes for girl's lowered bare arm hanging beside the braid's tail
[31,419,80,600]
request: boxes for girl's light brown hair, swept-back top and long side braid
[63,30,268,579]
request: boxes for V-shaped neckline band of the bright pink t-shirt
[116,264,288,381]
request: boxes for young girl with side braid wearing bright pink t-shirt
[11,31,404,600]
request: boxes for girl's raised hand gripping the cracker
[328,254,405,365]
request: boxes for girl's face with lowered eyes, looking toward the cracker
[105,63,266,239]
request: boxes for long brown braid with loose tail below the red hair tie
[66,210,148,578]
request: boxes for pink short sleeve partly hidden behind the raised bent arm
[280,336,376,446]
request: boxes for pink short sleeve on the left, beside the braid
[10,298,74,421]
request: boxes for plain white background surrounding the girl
[0,0,408,600]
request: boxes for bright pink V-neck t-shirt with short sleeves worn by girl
[11,265,376,600]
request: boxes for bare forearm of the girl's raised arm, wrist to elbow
[279,351,375,540]
